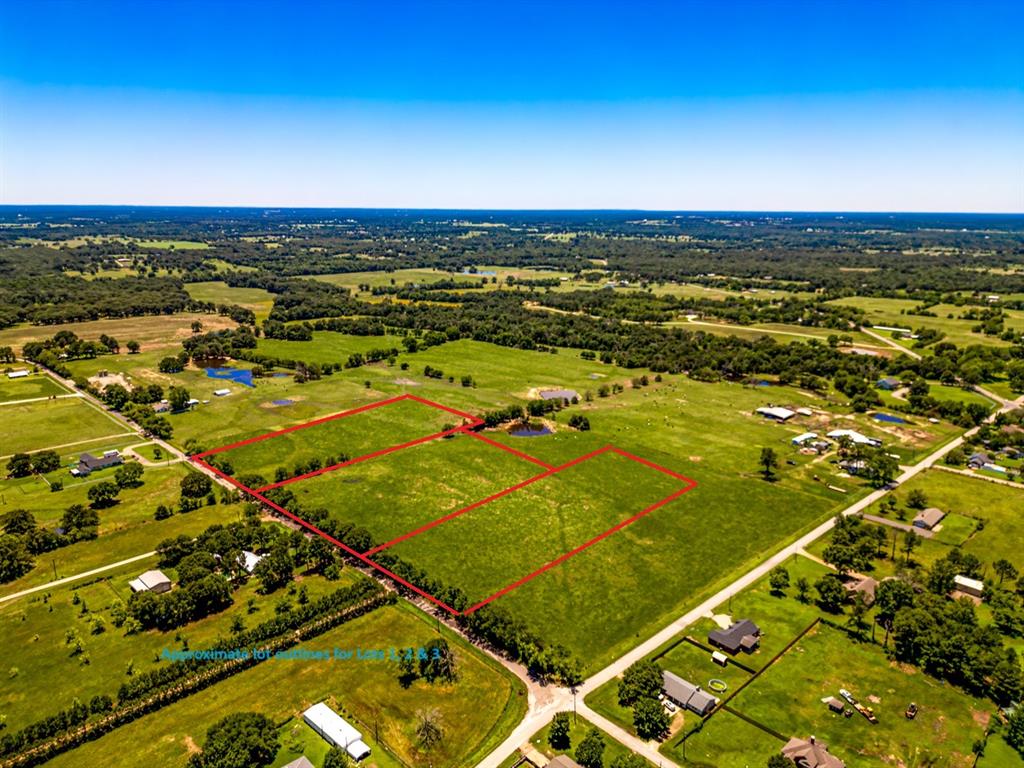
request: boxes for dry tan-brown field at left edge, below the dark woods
[0,312,236,356]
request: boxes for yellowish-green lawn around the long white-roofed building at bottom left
[43,605,526,768]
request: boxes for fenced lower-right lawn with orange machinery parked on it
[731,625,992,768]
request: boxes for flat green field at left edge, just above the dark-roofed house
[0,397,129,457]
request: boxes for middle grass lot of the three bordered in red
[288,434,545,543]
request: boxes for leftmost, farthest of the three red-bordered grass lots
[214,400,463,482]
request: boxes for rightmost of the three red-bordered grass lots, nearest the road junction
[391,452,685,603]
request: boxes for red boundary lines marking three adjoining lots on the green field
[189,394,697,616]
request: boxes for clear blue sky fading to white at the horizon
[0,0,1024,212]
